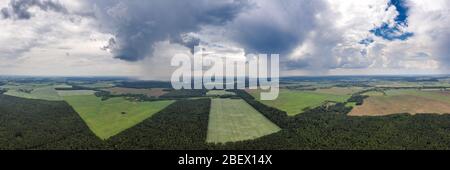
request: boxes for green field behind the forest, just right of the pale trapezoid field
[250,89,350,116]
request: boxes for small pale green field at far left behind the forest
[5,86,62,101]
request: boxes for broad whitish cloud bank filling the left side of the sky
[0,1,138,76]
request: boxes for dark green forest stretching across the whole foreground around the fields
[0,91,450,149]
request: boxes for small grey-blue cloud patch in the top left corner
[0,0,67,19]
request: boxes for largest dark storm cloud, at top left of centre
[95,0,249,61]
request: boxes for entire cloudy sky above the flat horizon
[0,0,450,79]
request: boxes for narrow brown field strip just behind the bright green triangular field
[103,87,168,97]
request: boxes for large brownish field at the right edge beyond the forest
[349,89,450,116]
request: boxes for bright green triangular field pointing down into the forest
[64,95,173,139]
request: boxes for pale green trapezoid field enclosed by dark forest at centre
[206,99,280,143]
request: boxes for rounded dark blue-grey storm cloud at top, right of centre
[225,0,327,54]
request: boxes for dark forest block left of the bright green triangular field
[0,95,103,149]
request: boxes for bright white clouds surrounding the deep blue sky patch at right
[289,0,450,74]
